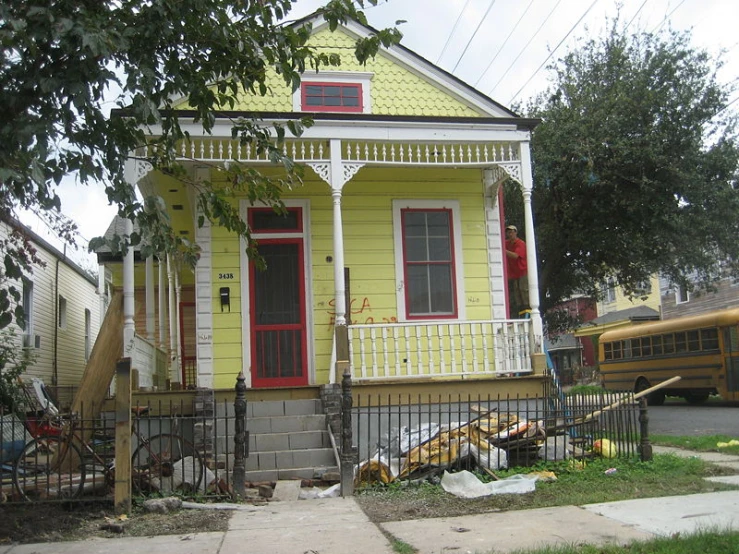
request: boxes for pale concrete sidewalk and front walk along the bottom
[0,448,739,554]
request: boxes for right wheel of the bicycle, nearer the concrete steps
[131,434,205,494]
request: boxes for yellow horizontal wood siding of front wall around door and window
[205,168,494,388]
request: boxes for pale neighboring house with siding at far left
[0,216,102,387]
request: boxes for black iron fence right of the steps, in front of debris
[352,393,639,483]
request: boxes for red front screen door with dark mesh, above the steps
[249,237,308,387]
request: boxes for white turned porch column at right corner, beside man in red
[521,141,544,352]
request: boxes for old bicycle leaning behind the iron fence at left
[13,408,205,501]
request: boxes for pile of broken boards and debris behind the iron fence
[355,412,546,485]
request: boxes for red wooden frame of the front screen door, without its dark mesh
[249,237,308,388]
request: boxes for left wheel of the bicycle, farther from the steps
[13,436,85,501]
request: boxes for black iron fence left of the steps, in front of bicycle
[0,401,235,502]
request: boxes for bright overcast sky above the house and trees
[26,0,739,266]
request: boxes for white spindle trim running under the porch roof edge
[141,138,521,166]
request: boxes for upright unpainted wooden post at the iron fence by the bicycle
[114,358,131,514]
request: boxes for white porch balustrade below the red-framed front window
[349,320,532,379]
